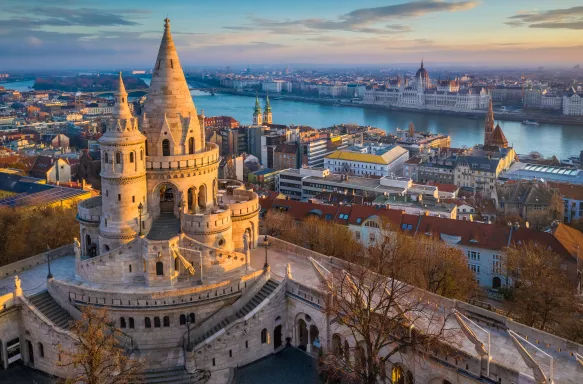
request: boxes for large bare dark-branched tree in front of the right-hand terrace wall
[322,248,456,384]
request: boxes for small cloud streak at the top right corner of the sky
[506,6,583,30]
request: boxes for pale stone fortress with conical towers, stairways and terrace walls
[0,19,583,384]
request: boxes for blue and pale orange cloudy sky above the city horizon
[0,0,583,73]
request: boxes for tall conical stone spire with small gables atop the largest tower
[141,18,205,156]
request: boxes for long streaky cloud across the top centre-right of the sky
[224,0,479,34]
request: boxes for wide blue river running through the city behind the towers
[0,79,583,159]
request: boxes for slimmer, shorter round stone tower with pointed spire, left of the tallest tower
[99,73,148,253]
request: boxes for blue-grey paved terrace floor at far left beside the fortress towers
[0,255,75,296]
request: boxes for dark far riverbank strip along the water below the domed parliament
[208,88,583,127]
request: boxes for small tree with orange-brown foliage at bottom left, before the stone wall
[58,307,144,384]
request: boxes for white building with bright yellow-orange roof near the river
[324,145,409,177]
